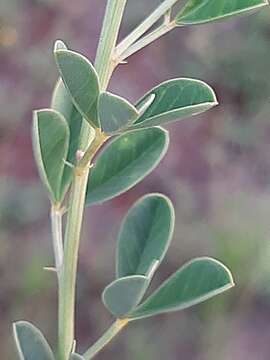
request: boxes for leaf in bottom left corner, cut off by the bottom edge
[13,321,54,360]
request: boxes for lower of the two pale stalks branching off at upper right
[119,21,176,62]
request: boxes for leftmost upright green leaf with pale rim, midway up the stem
[33,109,69,203]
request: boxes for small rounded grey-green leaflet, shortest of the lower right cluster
[102,275,149,318]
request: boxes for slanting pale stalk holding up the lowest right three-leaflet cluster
[83,319,129,360]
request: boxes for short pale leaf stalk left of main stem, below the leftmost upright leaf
[51,204,64,276]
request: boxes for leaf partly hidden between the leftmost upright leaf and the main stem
[51,79,82,194]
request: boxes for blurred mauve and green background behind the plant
[0,0,270,360]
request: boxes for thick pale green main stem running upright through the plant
[56,0,127,360]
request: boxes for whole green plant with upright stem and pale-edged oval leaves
[14,0,268,360]
